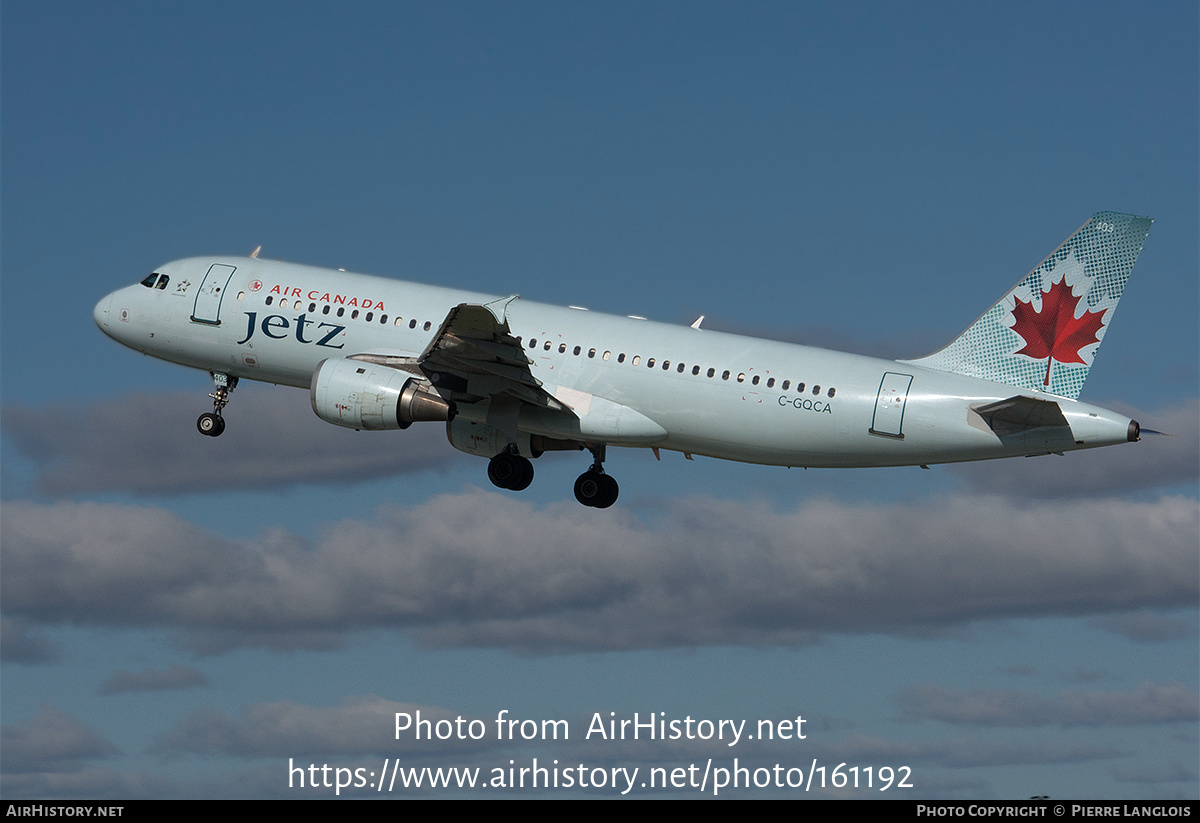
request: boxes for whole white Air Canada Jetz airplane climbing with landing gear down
[94,211,1152,509]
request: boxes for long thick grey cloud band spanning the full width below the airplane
[0,489,1200,653]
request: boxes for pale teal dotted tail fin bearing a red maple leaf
[905,211,1153,400]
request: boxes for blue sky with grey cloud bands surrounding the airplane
[0,0,1200,798]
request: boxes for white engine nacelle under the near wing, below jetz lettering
[310,358,455,431]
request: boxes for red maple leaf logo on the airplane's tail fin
[1013,281,1108,386]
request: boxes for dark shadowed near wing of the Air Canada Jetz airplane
[354,295,565,412]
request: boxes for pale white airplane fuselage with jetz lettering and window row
[96,258,1136,484]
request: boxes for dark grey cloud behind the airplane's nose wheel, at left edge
[4,384,466,495]
